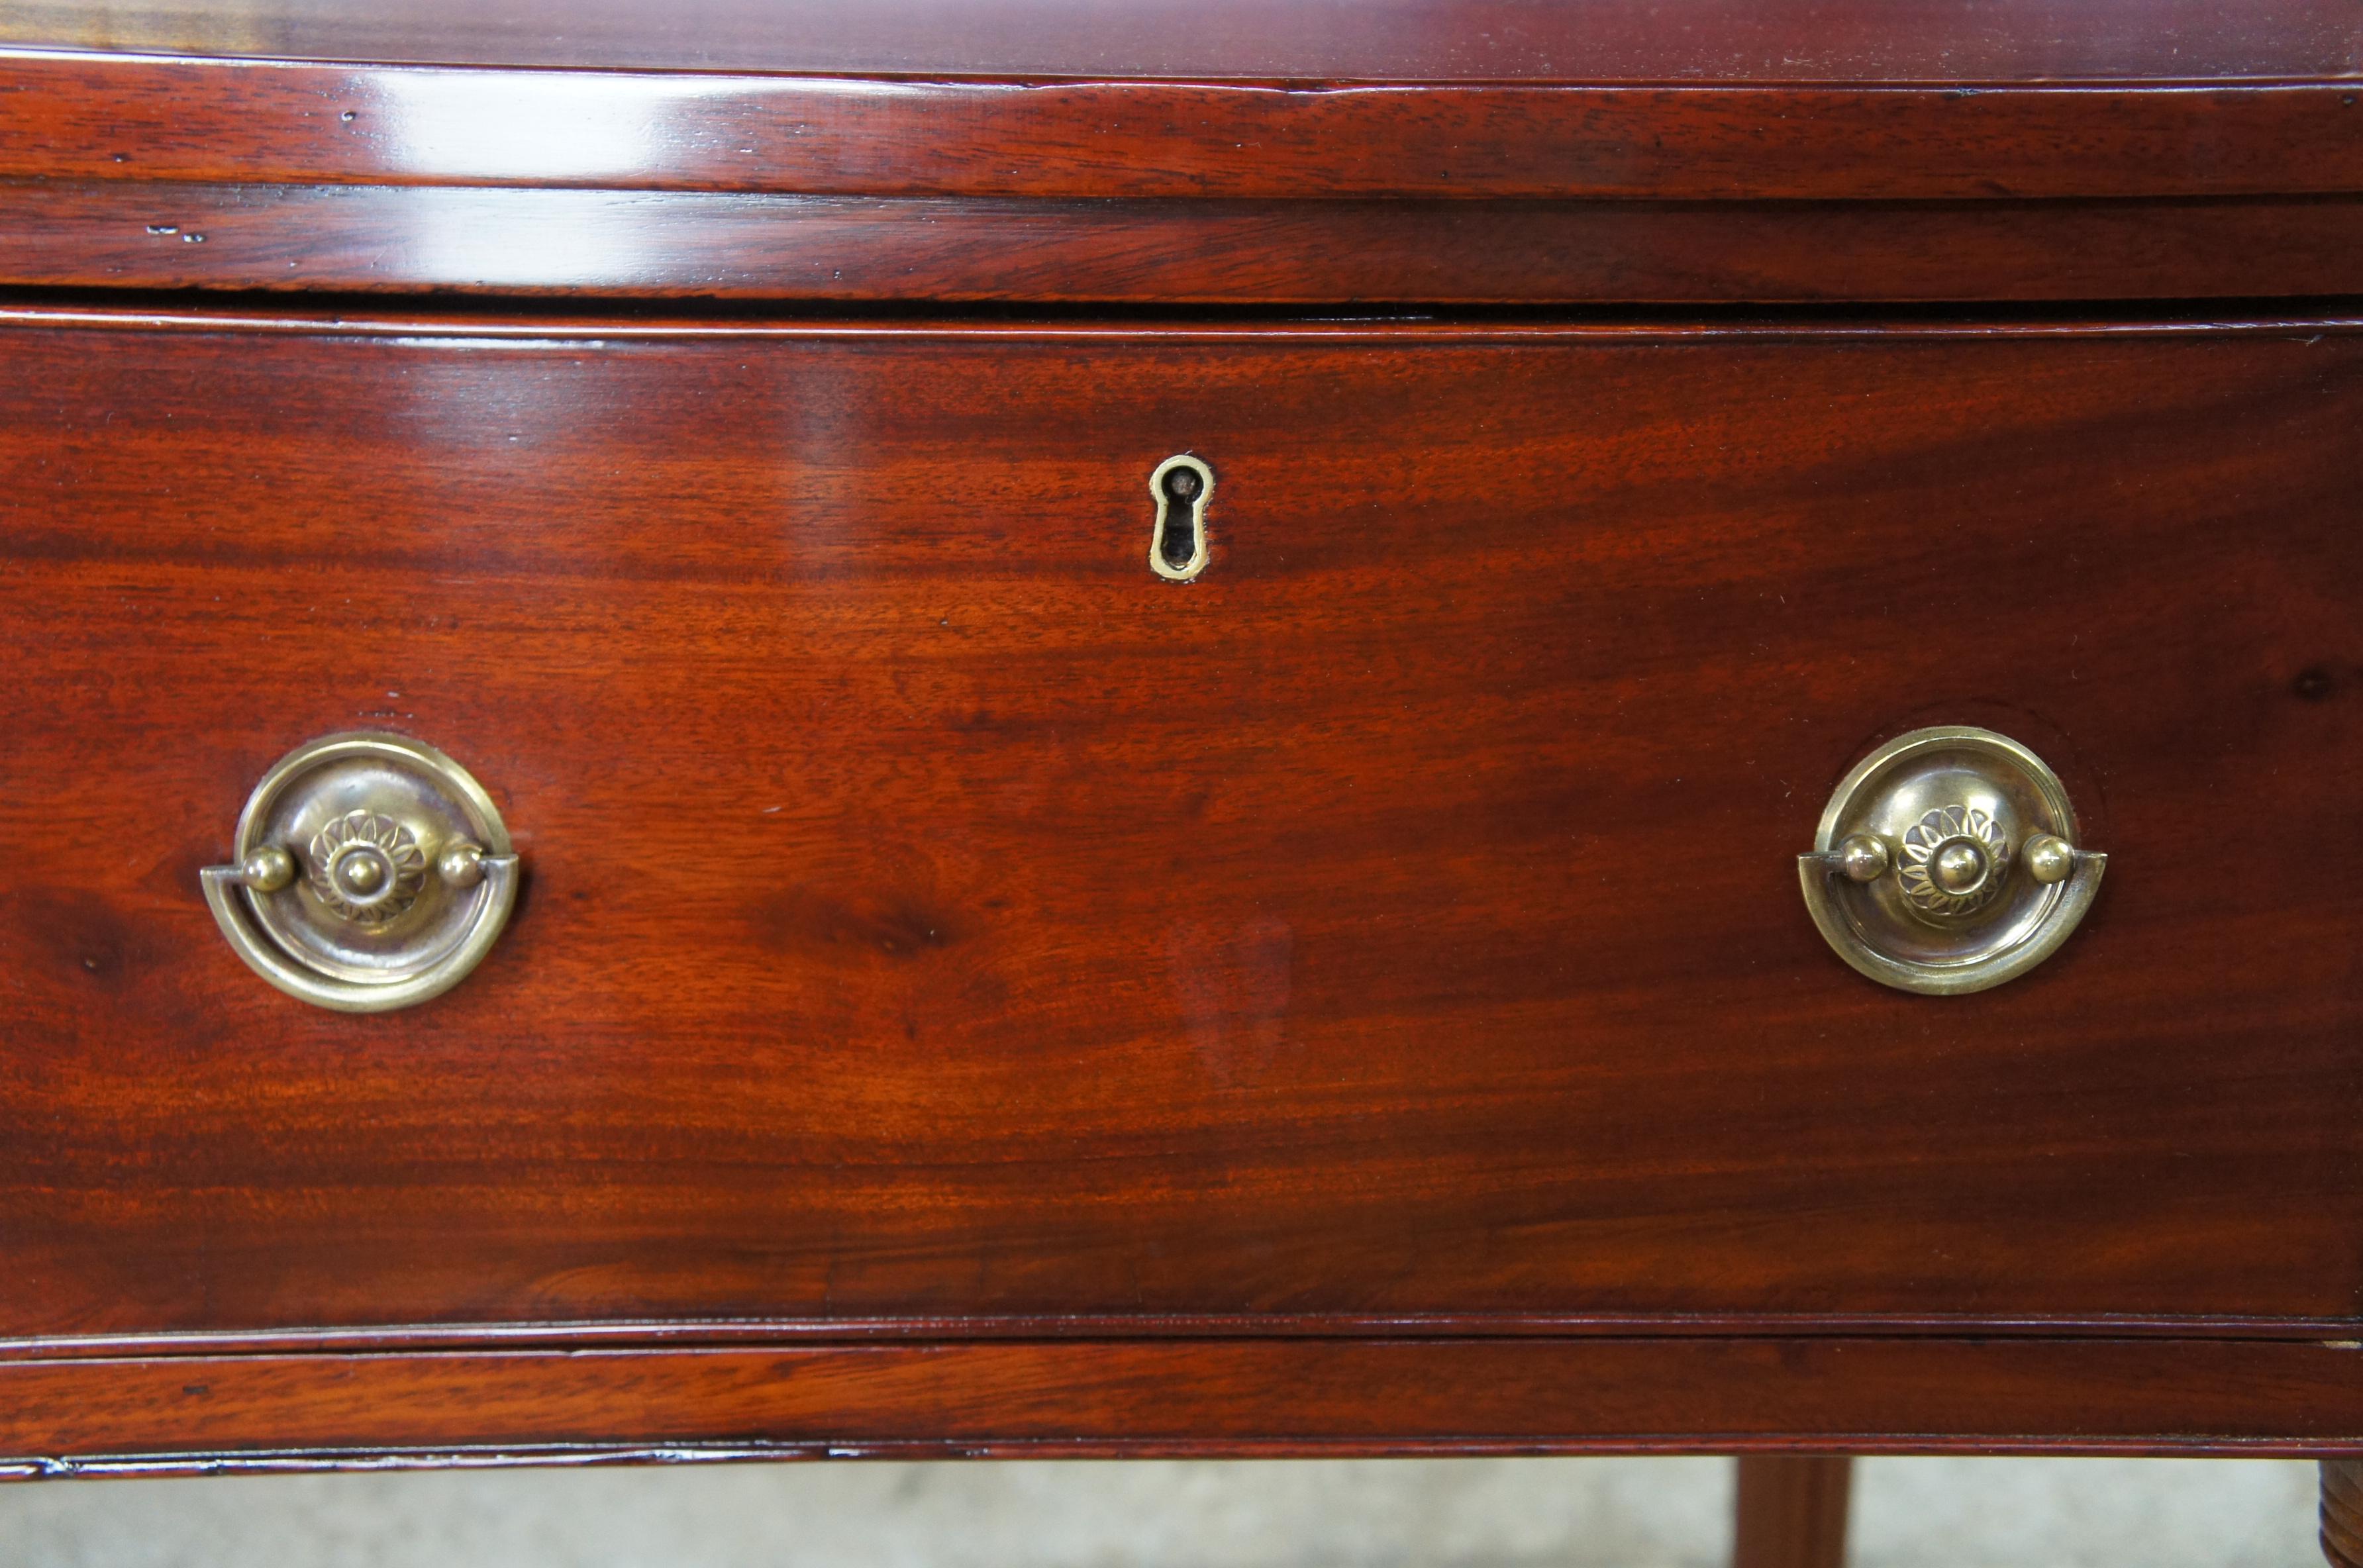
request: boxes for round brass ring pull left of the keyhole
[201,734,517,1013]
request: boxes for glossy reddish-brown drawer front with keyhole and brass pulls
[0,312,2363,1337]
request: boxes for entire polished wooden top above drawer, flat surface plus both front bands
[0,0,2363,305]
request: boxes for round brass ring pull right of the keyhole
[1796,727,2108,997]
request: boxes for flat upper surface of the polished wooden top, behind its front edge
[0,0,2363,83]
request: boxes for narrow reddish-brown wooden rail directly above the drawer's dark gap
[13,179,2363,305]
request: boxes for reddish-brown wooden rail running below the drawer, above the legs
[0,1339,2363,1473]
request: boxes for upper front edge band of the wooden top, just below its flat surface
[0,52,2363,201]
